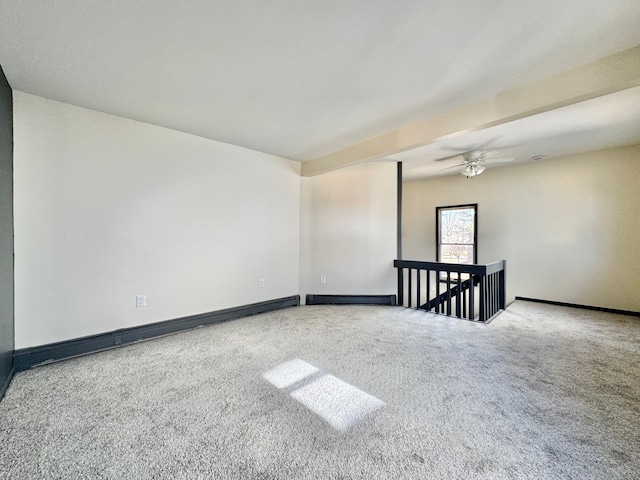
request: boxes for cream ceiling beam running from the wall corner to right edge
[302,46,640,176]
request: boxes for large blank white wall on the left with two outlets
[14,92,300,348]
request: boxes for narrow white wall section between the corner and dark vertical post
[300,163,396,300]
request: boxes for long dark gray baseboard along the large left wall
[13,295,300,372]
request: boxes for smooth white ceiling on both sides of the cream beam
[0,0,640,178]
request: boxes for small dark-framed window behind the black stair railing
[436,204,478,264]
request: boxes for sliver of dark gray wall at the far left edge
[0,63,14,388]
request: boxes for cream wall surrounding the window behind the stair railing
[403,145,640,311]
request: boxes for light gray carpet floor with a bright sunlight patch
[0,301,640,479]
